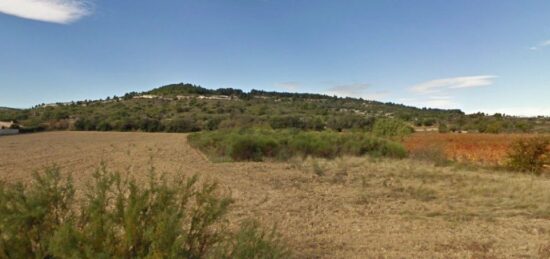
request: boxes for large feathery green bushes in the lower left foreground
[0,167,288,258]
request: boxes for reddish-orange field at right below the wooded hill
[404,133,550,165]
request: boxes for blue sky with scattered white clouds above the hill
[0,0,550,116]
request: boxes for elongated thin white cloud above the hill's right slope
[410,75,496,94]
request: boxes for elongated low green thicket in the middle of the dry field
[188,129,407,161]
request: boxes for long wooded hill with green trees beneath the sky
[0,83,550,133]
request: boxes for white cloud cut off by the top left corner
[0,0,90,24]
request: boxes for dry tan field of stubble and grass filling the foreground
[0,132,550,258]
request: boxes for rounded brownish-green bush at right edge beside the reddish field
[508,137,550,173]
